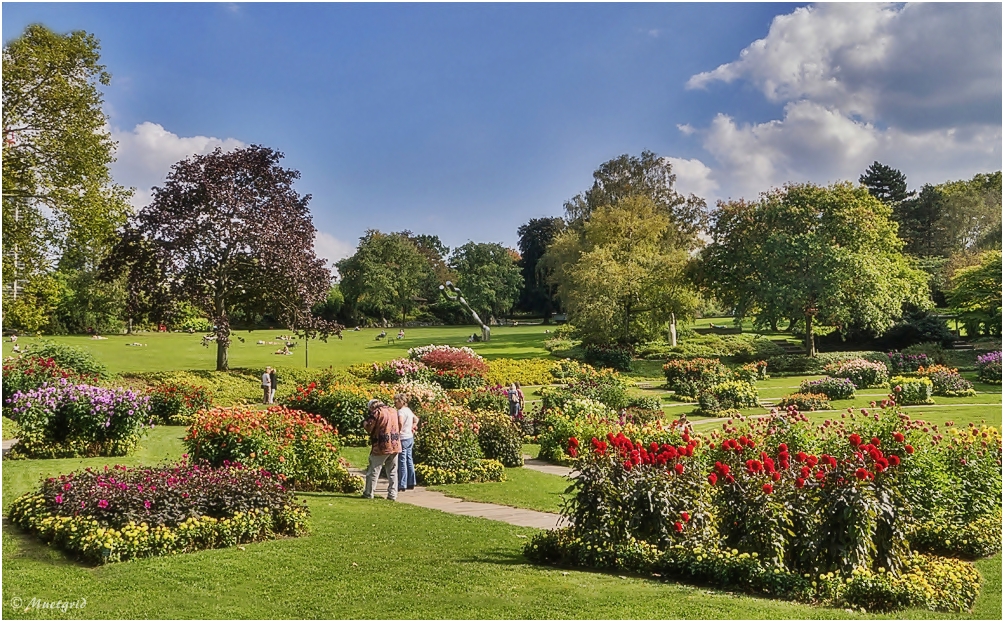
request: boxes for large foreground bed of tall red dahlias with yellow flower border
[524,408,1001,611]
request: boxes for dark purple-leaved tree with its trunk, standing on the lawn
[109,144,331,370]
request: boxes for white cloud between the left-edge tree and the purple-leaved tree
[111,121,244,208]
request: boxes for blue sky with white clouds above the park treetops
[2,2,1002,270]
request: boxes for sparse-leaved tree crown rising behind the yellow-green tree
[564,150,707,249]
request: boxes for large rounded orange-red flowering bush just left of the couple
[185,406,362,493]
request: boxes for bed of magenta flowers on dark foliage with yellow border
[9,461,308,564]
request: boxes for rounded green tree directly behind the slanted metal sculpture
[450,242,523,322]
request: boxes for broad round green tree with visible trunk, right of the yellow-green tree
[701,183,930,355]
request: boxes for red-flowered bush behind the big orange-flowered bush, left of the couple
[280,382,394,446]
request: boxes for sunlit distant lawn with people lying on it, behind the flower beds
[3,326,548,373]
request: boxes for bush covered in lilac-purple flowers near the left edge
[8,378,152,457]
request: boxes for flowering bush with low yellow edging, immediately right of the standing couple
[415,406,505,485]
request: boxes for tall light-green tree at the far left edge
[3,24,130,331]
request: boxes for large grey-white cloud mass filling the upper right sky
[680,3,1001,201]
